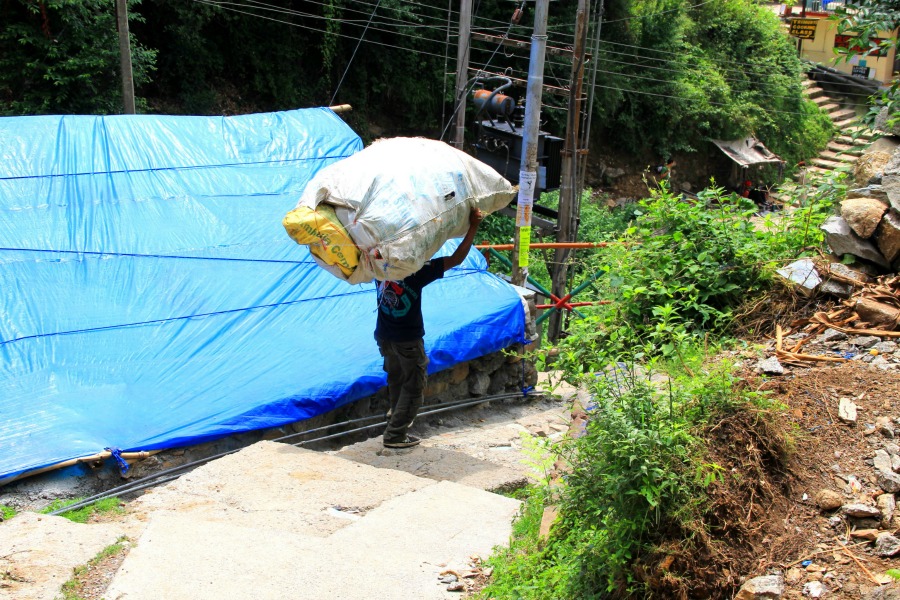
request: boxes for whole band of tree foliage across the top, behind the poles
[0,0,827,164]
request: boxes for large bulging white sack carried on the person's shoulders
[297,138,516,283]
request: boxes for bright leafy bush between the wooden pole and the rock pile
[559,174,846,370]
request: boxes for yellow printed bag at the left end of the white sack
[281,204,359,277]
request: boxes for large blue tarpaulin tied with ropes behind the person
[0,109,524,482]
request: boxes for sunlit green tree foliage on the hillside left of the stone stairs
[600,0,830,161]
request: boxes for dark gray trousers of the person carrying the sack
[376,339,428,442]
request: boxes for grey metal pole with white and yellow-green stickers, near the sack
[512,0,550,285]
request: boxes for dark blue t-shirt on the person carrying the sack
[375,258,444,342]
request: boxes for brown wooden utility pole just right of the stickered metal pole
[547,0,590,342]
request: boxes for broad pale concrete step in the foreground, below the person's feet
[104,442,520,600]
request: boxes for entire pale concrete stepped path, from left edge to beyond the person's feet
[0,390,576,600]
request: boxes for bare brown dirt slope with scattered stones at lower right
[640,362,900,600]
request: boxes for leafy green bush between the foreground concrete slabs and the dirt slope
[482,354,752,599]
